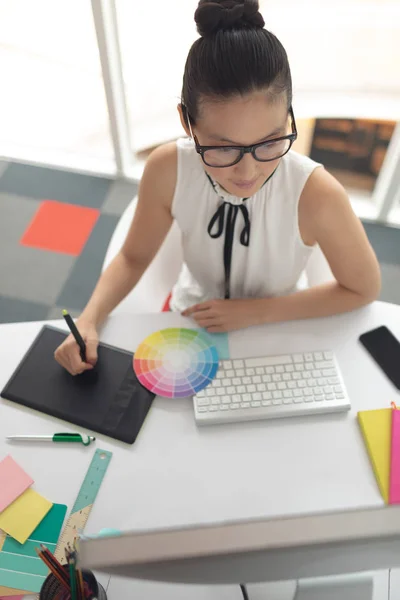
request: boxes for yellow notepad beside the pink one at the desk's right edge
[357,408,392,504]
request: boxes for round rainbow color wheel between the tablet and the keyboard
[133,328,218,398]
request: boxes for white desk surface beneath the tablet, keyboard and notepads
[0,302,400,600]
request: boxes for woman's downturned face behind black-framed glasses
[181,91,291,197]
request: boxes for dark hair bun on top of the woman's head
[194,0,265,37]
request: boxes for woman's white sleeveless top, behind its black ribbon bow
[170,138,320,311]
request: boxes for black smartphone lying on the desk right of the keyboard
[359,325,400,390]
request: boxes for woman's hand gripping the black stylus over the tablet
[54,319,99,375]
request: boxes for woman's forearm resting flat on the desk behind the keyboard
[260,281,379,323]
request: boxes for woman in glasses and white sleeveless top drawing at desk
[55,0,380,374]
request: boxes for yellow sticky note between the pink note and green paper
[0,488,53,544]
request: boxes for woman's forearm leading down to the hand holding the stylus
[79,252,145,326]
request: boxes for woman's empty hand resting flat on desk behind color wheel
[182,298,262,333]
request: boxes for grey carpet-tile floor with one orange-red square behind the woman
[0,161,400,323]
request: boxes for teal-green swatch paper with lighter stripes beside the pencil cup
[0,504,67,600]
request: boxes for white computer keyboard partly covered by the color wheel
[193,351,350,425]
